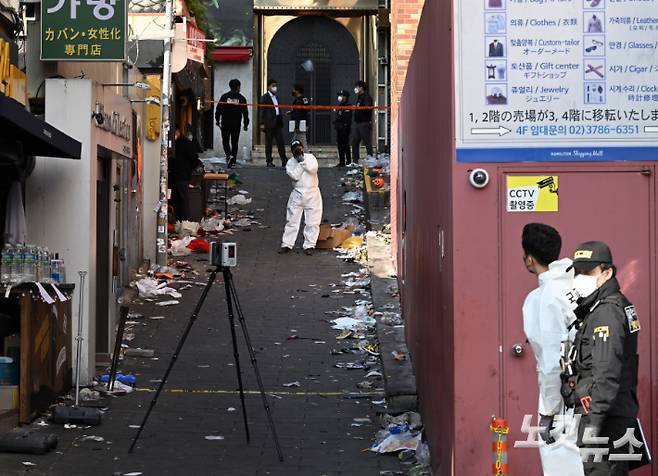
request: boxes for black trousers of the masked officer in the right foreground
[578,415,639,476]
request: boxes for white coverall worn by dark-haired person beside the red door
[523,258,583,476]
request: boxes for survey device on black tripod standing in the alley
[128,256,283,461]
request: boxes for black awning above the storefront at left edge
[0,94,82,159]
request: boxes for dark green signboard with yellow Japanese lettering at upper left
[41,0,127,61]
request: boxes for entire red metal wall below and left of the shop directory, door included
[396,0,658,476]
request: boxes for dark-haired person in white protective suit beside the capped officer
[521,223,583,476]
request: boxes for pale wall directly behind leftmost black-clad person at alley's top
[213,59,254,160]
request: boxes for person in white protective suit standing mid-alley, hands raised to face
[279,140,322,255]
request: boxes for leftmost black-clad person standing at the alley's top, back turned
[215,79,249,168]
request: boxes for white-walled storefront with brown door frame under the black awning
[26,79,136,383]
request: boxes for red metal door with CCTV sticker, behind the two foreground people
[499,166,656,474]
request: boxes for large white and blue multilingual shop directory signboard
[454,0,658,162]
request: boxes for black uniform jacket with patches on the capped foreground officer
[574,278,640,426]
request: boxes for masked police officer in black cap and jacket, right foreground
[563,241,640,476]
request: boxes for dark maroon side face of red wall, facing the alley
[397,0,455,474]
